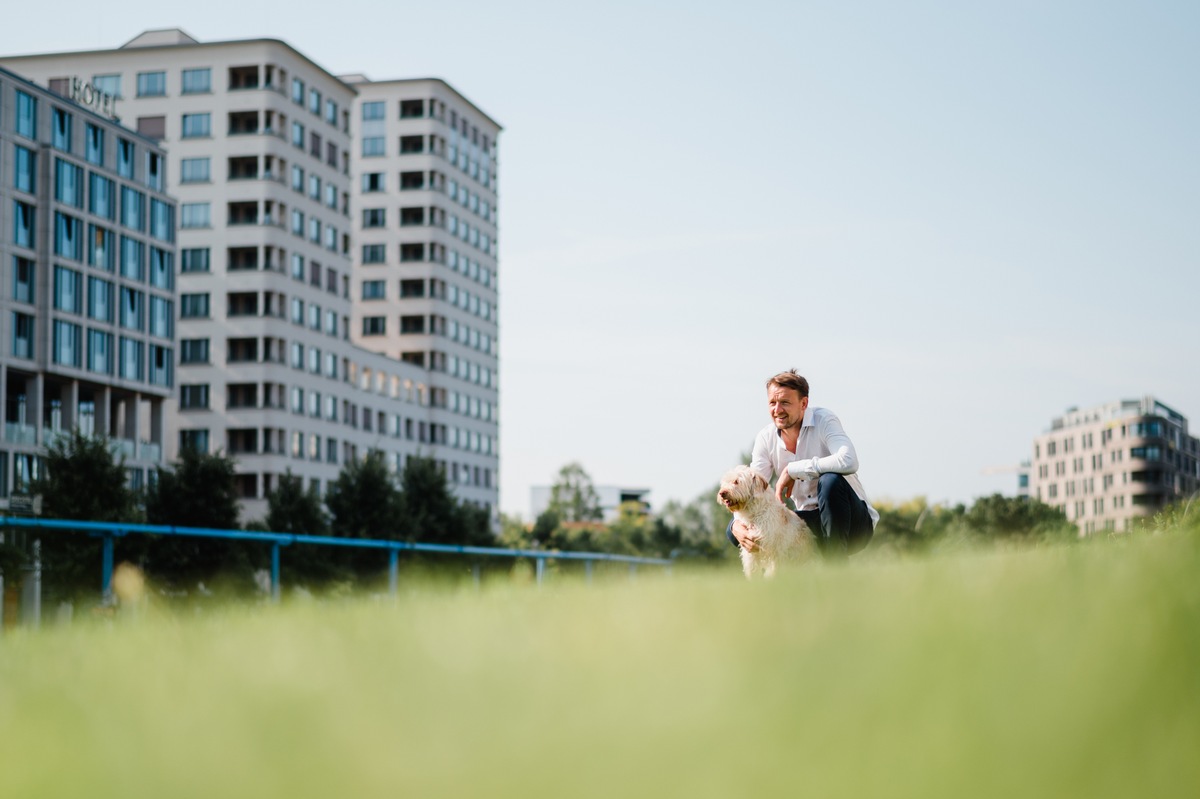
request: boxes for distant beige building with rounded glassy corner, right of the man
[1030,396,1200,534]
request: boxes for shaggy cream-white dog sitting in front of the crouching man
[716,465,816,577]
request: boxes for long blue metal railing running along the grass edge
[0,516,673,601]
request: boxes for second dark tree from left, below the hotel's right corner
[145,447,247,588]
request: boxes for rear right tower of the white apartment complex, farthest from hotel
[342,74,500,501]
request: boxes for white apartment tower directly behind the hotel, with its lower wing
[0,30,498,518]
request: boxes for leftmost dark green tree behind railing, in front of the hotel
[30,429,138,595]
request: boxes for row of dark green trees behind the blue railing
[0,432,496,600]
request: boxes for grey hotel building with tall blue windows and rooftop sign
[0,68,176,499]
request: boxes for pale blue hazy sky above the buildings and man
[0,0,1200,518]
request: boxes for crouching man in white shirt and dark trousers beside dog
[727,370,880,557]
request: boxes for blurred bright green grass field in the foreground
[0,533,1200,799]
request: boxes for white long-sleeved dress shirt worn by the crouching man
[750,405,880,527]
